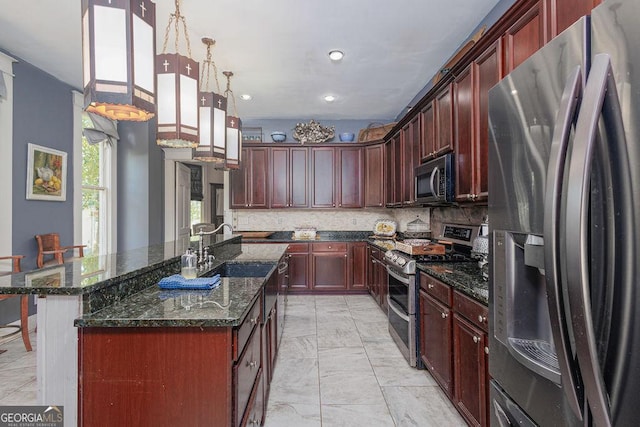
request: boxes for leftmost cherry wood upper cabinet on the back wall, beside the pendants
[230,147,269,208]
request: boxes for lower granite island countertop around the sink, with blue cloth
[75,243,287,327]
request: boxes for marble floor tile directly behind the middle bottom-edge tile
[320,371,386,405]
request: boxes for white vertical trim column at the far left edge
[0,52,16,262]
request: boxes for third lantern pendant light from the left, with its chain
[193,37,227,163]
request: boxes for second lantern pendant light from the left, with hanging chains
[156,0,200,148]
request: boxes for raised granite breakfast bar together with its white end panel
[0,235,284,426]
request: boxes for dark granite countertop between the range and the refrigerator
[416,262,489,305]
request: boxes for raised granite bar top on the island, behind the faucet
[0,235,241,295]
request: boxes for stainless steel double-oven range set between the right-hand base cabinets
[384,224,479,368]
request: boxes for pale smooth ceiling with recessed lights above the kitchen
[0,0,499,120]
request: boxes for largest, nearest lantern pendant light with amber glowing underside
[82,0,156,122]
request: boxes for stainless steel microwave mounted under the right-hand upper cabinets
[415,153,455,205]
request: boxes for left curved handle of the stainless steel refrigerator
[544,67,583,420]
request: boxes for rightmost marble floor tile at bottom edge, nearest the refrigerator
[382,386,466,427]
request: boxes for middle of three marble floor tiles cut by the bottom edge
[322,404,394,427]
